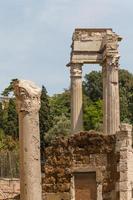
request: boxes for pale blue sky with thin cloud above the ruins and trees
[0,0,133,94]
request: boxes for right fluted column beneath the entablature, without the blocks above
[103,58,120,135]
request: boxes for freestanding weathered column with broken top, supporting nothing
[14,80,42,200]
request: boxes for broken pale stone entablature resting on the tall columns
[70,28,122,65]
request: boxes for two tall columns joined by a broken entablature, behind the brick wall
[67,29,122,134]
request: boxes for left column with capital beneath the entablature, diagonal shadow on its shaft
[70,64,83,133]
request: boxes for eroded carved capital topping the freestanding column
[14,80,41,113]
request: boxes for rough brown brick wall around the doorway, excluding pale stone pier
[42,131,119,200]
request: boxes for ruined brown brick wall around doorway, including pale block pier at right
[42,124,133,200]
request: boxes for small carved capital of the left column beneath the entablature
[70,63,82,77]
